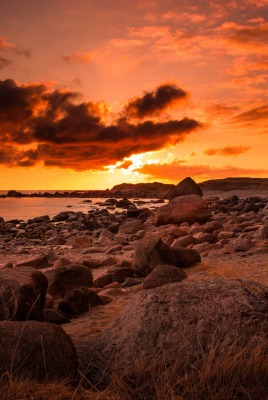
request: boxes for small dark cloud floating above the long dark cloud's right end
[125,84,187,118]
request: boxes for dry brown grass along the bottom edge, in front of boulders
[0,338,268,400]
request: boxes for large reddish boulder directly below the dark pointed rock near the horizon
[154,195,211,226]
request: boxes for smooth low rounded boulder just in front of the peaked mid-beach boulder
[143,264,187,289]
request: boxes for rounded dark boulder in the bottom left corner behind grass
[0,321,78,382]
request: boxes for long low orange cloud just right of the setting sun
[135,160,268,183]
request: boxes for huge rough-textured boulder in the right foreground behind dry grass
[87,279,268,382]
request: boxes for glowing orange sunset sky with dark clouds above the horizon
[0,0,268,190]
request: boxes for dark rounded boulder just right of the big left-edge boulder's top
[44,264,93,297]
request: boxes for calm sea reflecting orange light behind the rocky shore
[0,190,163,221]
